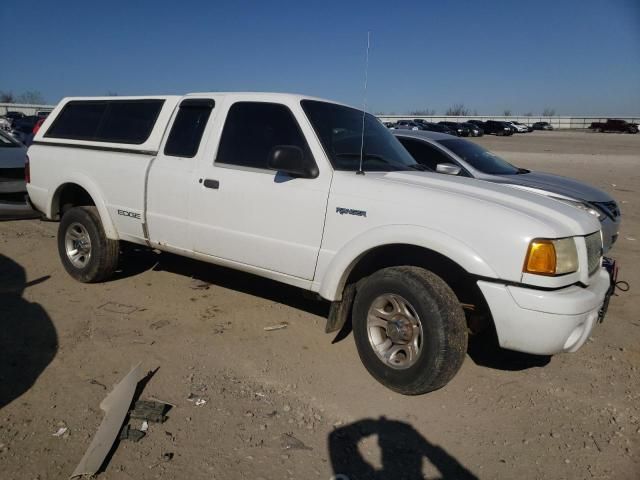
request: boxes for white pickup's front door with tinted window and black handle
[191,101,331,280]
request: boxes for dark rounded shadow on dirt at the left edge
[0,254,58,408]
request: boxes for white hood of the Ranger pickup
[366,171,600,237]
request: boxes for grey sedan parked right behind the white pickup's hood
[394,132,620,253]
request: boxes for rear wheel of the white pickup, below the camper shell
[58,207,119,283]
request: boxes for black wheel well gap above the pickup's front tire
[342,244,491,331]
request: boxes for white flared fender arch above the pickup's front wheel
[318,225,498,301]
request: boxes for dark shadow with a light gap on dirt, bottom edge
[328,417,477,480]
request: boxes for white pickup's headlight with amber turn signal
[522,237,578,276]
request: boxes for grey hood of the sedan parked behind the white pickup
[483,172,613,202]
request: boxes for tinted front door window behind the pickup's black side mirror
[215,102,315,170]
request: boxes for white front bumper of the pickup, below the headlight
[478,268,611,355]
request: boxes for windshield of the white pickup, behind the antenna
[301,100,424,172]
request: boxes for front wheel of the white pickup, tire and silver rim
[353,266,467,395]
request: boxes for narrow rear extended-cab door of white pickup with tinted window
[145,98,215,250]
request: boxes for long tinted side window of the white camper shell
[44,99,164,145]
